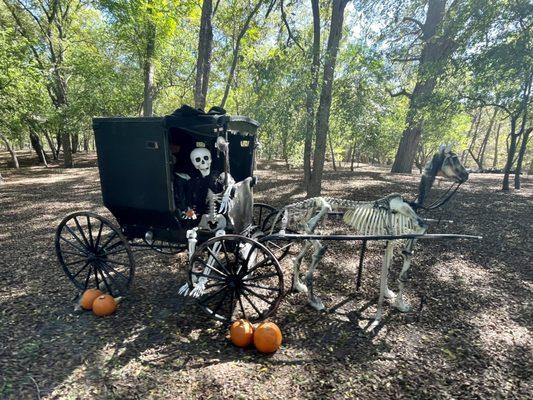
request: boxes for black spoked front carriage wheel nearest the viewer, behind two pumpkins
[189,235,284,322]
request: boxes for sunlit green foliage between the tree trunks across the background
[0,0,533,171]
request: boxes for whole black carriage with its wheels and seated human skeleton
[55,106,286,321]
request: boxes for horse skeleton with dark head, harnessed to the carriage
[272,146,468,327]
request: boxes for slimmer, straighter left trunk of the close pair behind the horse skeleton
[304,0,320,191]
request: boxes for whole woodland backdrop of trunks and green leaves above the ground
[0,0,533,195]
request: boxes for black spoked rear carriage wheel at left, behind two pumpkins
[55,211,135,297]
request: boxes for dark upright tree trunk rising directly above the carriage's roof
[194,0,213,110]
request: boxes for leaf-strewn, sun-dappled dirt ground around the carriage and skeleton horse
[0,155,533,399]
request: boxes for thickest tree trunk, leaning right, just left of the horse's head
[391,0,450,173]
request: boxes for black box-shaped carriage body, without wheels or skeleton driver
[93,109,258,243]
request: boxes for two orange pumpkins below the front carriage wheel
[230,319,283,353]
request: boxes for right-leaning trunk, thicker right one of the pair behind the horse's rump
[307,0,348,197]
